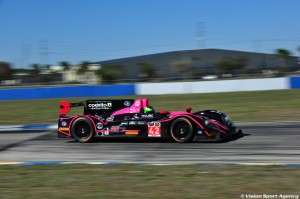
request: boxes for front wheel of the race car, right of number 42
[170,117,195,143]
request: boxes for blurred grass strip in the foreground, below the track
[0,164,300,199]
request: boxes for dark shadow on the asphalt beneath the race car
[67,133,251,143]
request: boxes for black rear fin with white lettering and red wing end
[59,99,134,116]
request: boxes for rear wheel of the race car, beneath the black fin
[71,117,95,143]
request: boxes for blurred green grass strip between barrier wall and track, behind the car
[0,89,300,125]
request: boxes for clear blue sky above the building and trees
[0,0,300,68]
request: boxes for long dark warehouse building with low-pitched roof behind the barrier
[94,49,300,80]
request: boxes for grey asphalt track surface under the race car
[0,122,300,164]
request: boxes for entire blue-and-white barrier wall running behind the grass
[0,77,300,100]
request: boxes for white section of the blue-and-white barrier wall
[136,78,290,95]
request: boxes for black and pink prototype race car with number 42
[58,98,242,143]
